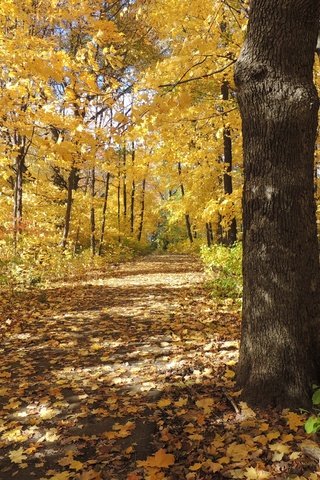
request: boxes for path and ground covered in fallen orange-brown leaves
[0,255,320,480]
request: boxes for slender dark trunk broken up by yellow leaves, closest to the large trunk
[221,81,237,246]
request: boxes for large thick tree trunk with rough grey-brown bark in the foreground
[235,0,320,407]
